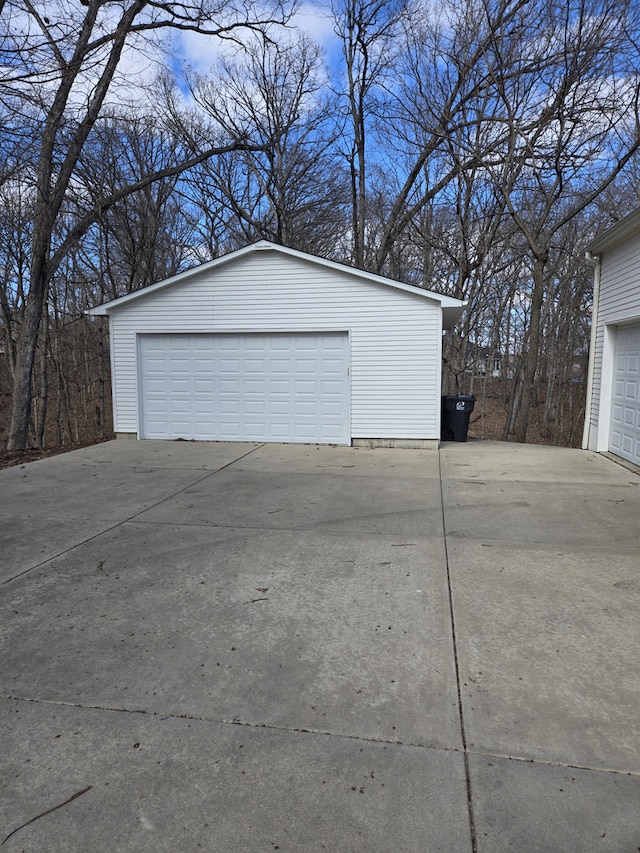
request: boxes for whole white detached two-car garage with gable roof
[89,242,464,447]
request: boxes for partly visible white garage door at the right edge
[609,326,640,465]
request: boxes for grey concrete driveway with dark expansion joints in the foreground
[0,441,640,853]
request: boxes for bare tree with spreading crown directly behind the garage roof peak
[188,37,345,254]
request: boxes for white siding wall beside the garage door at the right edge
[587,234,640,451]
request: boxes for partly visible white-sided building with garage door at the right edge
[582,209,640,465]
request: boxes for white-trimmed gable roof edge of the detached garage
[87,240,467,329]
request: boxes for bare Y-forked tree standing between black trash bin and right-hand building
[485,0,640,441]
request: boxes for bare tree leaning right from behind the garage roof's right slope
[364,0,536,272]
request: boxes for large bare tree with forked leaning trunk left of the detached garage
[0,0,292,449]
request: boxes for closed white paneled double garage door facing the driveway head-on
[138,333,350,444]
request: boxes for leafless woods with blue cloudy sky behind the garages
[0,0,640,450]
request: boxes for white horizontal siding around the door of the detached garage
[106,252,442,439]
